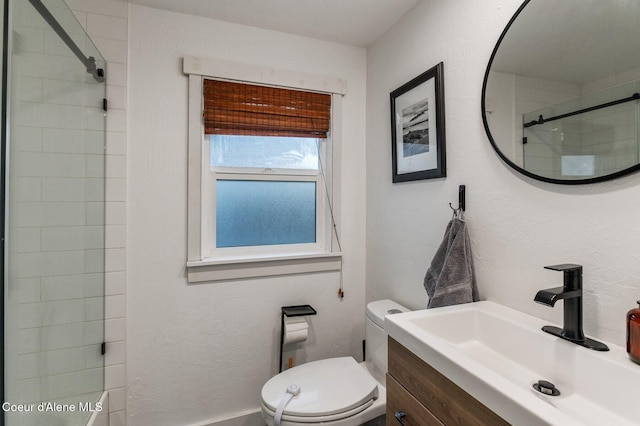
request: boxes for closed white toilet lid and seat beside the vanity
[262,357,378,417]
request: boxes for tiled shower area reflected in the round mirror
[504,70,640,178]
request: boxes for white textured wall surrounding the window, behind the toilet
[127,5,366,425]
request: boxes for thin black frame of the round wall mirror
[481,0,640,185]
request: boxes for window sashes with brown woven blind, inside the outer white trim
[203,79,331,258]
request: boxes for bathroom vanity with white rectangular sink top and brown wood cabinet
[385,301,640,426]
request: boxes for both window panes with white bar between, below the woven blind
[210,135,326,249]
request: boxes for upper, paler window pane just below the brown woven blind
[209,135,323,170]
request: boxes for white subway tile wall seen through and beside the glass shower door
[8,0,128,426]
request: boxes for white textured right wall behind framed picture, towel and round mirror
[367,0,640,345]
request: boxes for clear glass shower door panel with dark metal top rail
[0,0,106,426]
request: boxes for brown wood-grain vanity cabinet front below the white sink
[387,337,509,426]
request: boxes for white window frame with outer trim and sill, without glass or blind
[183,57,346,283]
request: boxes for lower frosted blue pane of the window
[216,180,316,247]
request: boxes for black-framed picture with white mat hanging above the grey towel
[391,62,447,183]
